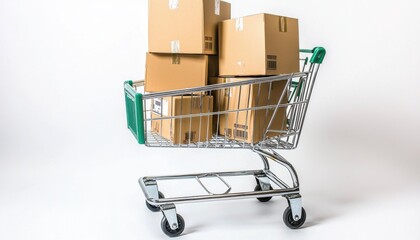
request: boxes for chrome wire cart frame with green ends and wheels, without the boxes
[124,47,326,237]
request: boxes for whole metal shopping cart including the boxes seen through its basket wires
[124,47,326,237]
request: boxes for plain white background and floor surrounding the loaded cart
[0,0,420,240]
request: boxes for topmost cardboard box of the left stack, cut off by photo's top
[149,0,230,54]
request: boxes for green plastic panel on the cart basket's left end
[124,80,145,144]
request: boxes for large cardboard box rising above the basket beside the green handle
[219,14,299,76]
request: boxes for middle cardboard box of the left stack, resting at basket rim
[144,53,218,92]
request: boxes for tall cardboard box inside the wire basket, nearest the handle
[209,78,287,143]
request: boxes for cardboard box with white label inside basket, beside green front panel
[151,96,213,144]
